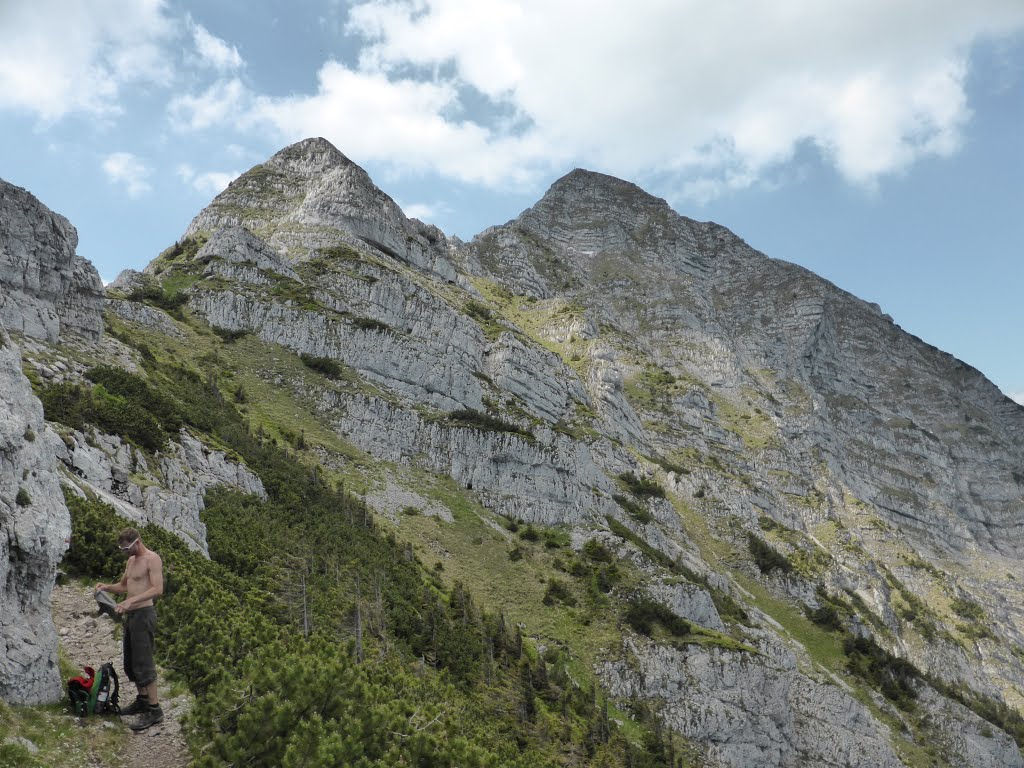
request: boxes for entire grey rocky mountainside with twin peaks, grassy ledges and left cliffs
[6,138,1024,768]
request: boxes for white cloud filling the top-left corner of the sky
[0,0,175,122]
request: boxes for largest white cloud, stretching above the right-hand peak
[335,0,1024,195]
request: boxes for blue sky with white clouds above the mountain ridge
[0,0,1024,403]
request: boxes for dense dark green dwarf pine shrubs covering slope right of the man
[56,346,681,767]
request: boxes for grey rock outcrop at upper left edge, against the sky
[0,179,103,342]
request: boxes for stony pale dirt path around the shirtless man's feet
[50,584,189,768]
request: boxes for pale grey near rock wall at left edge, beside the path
[0,328,71,703]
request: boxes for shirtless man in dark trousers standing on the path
[96,528,164,731]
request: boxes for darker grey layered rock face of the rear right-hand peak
[468,171,1024,559]
